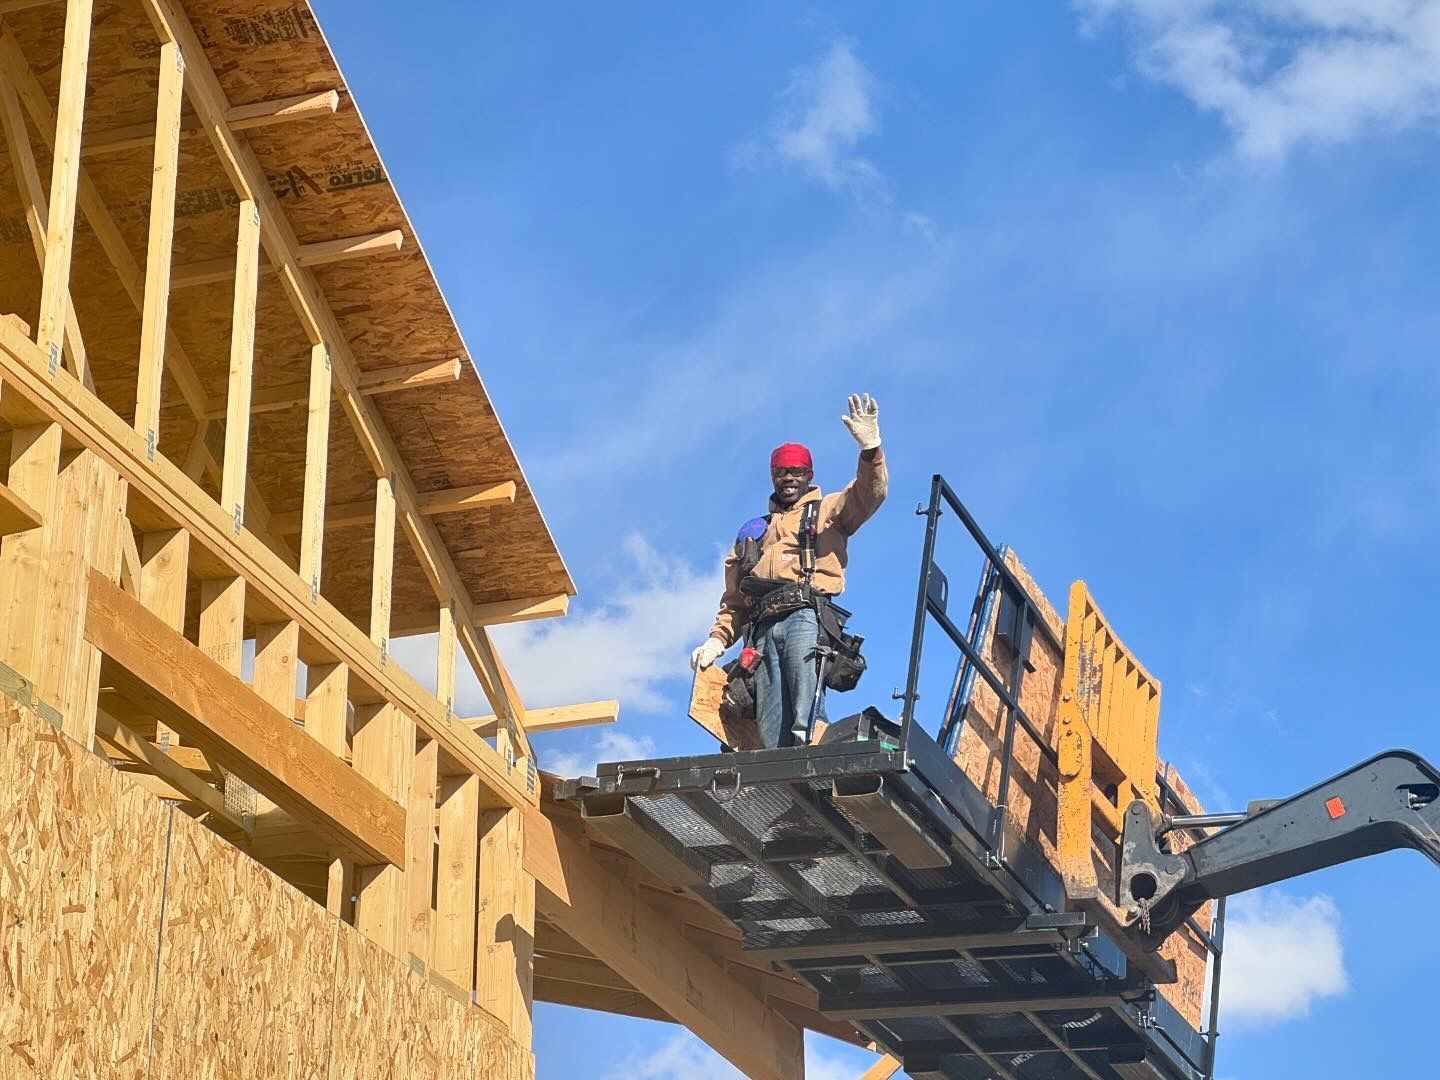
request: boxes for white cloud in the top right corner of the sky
[1076,0,1440,160]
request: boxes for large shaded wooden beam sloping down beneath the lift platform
[535,811,805,1080]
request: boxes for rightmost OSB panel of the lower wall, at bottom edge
[331,933,534,1080]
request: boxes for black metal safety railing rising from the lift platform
[899,474,1225,1080]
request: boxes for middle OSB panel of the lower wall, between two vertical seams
[154,815,336,1080]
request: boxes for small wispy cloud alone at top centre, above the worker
[737,39,884,199]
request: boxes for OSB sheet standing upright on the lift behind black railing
[955,552,1210,1028]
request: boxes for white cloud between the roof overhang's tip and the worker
[494,533,723,711]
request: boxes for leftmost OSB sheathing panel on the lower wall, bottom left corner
[0,698,170,1080]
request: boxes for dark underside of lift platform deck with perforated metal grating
[561,736,1202,1080]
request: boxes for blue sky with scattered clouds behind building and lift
[317,0,1440,1080]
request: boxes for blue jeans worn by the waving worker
[755,608,825,749]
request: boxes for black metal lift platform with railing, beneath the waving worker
[557,477,1223,1080]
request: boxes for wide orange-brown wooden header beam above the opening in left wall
[85,570,405,867]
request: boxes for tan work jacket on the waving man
[710,454,890,647]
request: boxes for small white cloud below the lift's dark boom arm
[1220,891,1349,1027]
